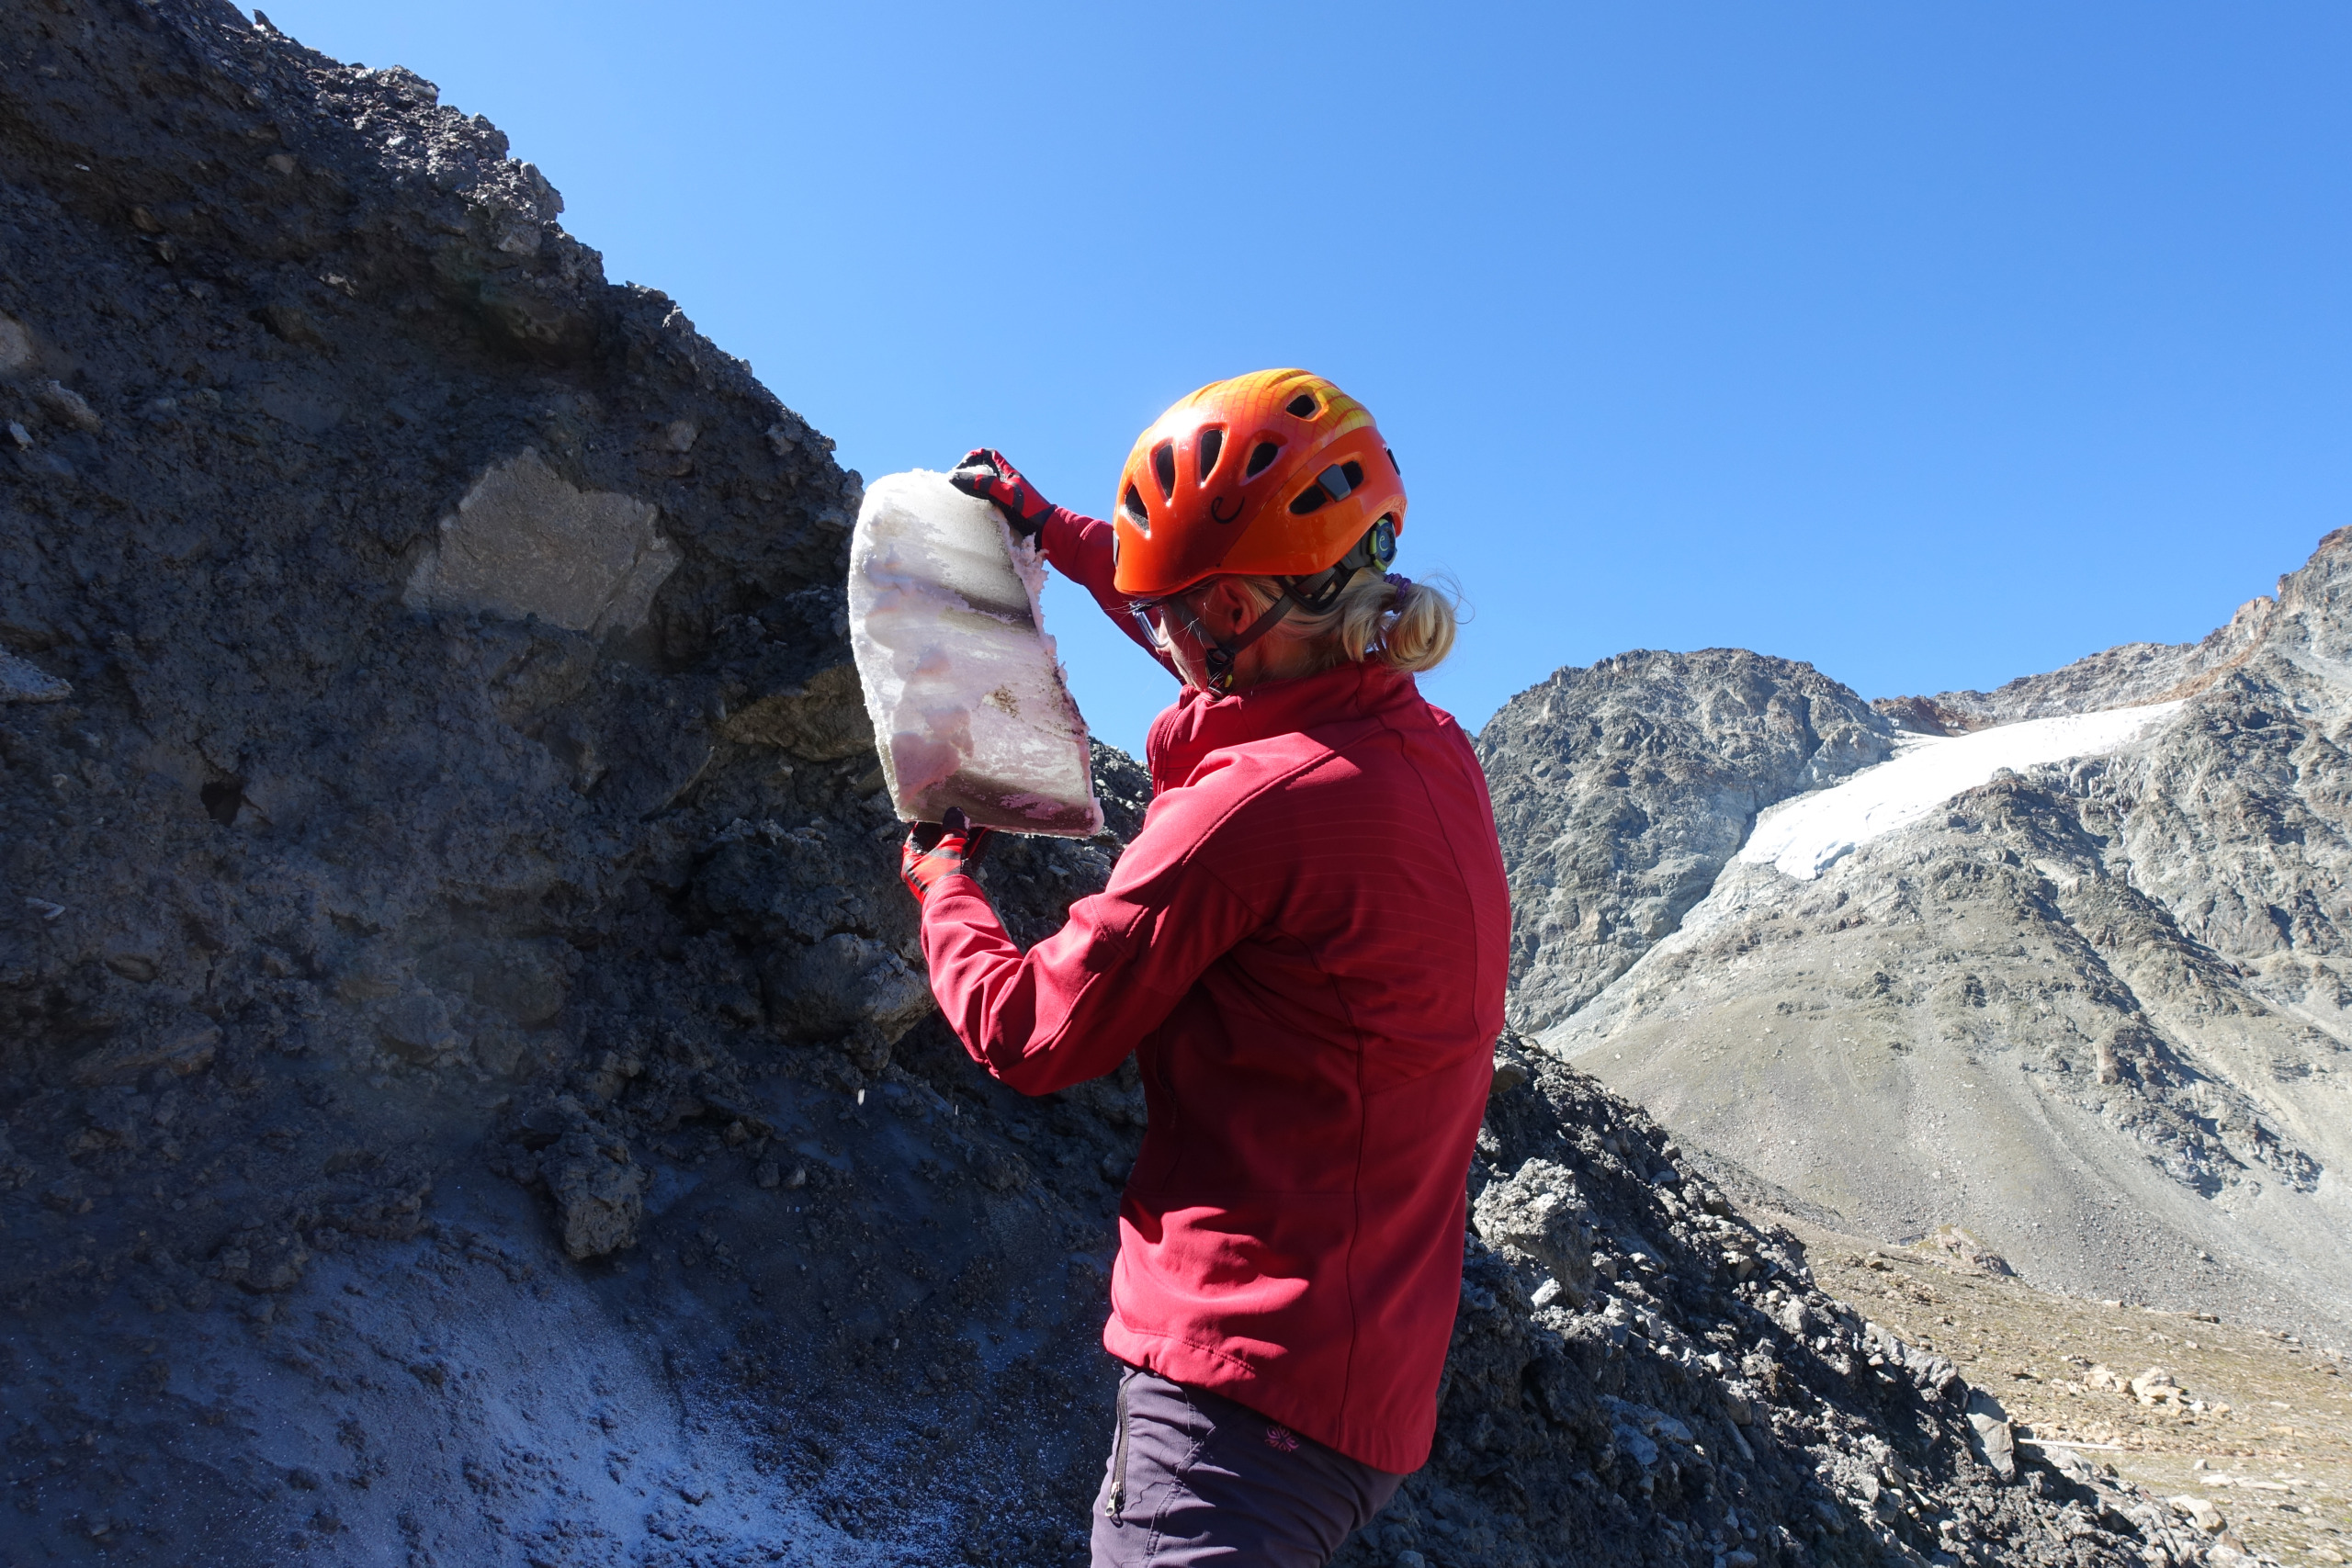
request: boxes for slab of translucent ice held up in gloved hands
[849,468,1103,837]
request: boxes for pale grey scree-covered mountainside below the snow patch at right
[1547,534,2352,1333]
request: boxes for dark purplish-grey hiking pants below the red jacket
[1093,1366,1404,1568]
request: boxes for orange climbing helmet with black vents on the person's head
[1110,369,1404,600]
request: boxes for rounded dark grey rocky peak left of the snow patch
[1477,649,1895,1030]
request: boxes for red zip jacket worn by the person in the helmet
[922,514,1510,1472]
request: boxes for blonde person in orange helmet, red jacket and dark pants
[903,369,1510,1568]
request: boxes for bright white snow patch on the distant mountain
[1740,703,2180,882]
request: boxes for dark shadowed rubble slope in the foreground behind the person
[0,0,2164,1568]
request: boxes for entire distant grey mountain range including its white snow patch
[1479,529,2352,1325]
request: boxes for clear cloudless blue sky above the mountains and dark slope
[270,0,2352,748]
